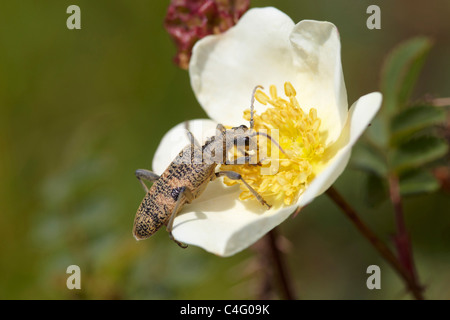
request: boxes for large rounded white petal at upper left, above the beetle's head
[189,7,295,126]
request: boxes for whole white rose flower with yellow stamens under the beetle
[153,7,382,256]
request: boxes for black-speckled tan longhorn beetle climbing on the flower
[133,86,284,248]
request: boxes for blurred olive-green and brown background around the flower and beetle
[0,0,450,299]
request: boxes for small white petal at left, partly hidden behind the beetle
[152,119,217,174]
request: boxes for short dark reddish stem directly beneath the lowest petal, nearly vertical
[265,228,296,300]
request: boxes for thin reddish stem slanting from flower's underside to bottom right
[326,187,424,300]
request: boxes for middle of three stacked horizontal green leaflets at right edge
[391,136,448,173]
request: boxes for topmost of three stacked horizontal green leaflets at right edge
[391,105,446,144]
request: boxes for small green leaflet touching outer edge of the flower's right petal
[351,143,388,177]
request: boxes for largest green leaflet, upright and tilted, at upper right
[381,37,432,114]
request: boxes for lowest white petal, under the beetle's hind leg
[173,180,295,257]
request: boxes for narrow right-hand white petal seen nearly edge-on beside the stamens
[297,92,382,207]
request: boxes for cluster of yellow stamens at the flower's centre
[221,82,324,206]
